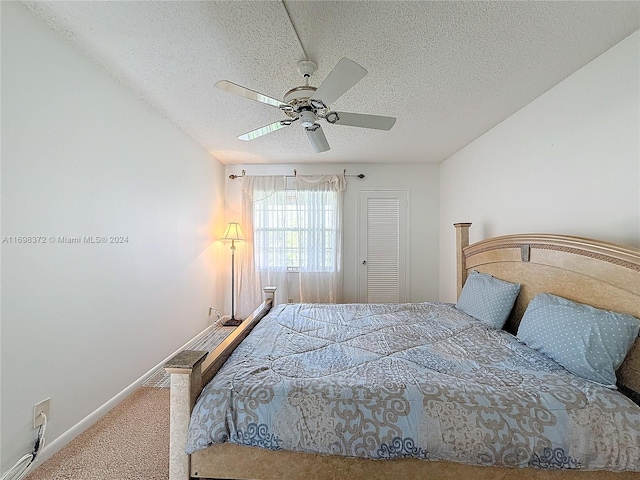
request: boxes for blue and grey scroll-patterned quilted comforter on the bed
[187,303,640,471]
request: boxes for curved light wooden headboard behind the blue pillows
[454,223,640,393]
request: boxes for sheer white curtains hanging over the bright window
[237,175,346,317]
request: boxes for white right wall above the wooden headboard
[440,32,640,301]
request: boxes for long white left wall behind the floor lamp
[0,2,224,472]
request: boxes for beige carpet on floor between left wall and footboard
[26,387,169,480]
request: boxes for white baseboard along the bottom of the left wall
[32,324,215,470]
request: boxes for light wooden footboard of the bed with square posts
[165,287,276,480]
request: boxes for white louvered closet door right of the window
[359,190,408,303]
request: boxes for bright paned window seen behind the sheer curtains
[253,190,339,272]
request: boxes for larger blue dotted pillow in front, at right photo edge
[518,293,640,388]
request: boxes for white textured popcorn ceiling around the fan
[23,1,640,164]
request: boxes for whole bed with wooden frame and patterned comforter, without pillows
[167,224,640,480]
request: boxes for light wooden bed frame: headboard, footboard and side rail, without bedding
[165,223,640,480]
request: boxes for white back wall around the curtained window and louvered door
[225,163,439,311]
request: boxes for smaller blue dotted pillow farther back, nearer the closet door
[456,272,520,330]
